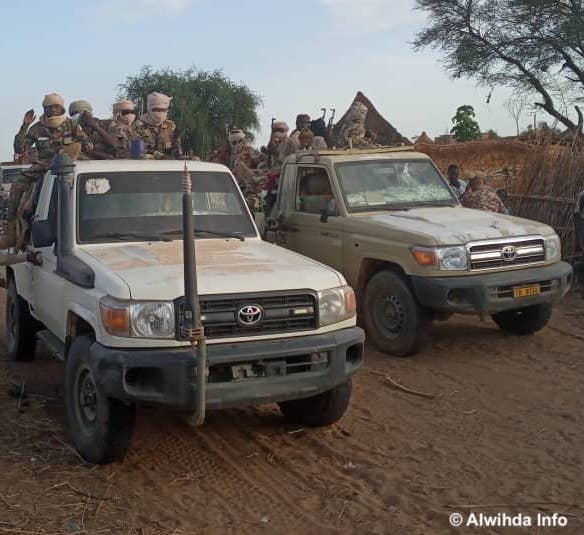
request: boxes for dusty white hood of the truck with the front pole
[82,239,345,300]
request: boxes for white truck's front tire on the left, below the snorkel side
[64,335,136,464]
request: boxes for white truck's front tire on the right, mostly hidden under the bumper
[278,379,352,427]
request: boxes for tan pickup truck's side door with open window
[283,165,343,270]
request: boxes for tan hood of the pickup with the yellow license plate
[355,206,554,245]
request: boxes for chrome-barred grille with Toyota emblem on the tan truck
[470,238,545,271]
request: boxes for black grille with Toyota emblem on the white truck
[175,291,318,338]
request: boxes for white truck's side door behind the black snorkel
[30,175,65,339]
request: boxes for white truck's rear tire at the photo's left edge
[4,278,40,361]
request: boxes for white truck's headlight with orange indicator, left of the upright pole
[99,297,174,338]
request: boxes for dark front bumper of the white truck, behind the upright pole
[90,327,365,410]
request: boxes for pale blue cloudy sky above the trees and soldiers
[0,0,530,160]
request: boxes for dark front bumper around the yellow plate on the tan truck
[411,262,572,314]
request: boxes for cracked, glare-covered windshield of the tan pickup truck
[336,160,458,212]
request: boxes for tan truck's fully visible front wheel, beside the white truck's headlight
[362,270,432,357]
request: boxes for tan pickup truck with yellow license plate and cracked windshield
[266,148,572,356]
